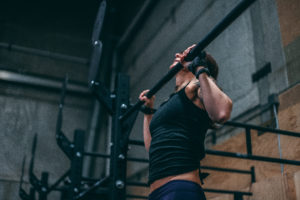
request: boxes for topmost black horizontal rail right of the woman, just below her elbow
[225,121,300,137]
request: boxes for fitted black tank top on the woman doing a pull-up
[149,88,211,184]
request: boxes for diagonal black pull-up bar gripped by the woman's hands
[119,0,256,121]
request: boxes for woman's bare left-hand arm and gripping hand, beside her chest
[139,90,155,152]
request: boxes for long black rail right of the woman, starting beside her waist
[205,149,300,165]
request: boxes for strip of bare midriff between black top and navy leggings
[150,169,201,193]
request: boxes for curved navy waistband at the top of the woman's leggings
[149,180,202,199]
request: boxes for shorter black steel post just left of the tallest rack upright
[68,130,84,200]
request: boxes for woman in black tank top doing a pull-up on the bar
[139,45,232,200]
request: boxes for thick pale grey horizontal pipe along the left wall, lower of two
[0,70,90,95]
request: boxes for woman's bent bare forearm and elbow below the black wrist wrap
[197,73,232,123]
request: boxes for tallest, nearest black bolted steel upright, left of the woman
[110,74,129,200]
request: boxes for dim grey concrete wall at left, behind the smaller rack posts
[0,20,106,200]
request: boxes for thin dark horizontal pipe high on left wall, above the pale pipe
[0,42,88,65]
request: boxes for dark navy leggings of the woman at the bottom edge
[149,180,206,200]
